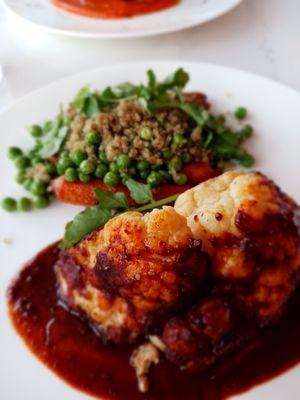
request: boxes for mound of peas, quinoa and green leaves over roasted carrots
[3,69,254,211]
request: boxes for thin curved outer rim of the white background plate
[0,0,243,39]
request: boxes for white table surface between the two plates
[0,0,300,107]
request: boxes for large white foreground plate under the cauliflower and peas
[0,62,300,400]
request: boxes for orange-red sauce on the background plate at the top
[52,0,179,18]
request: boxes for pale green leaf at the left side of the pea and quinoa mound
[38,113,69,159]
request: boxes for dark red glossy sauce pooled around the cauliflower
[8,243,300,400]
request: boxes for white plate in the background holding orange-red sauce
[3,0,241,38]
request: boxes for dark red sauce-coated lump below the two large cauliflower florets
[162,297,256,371]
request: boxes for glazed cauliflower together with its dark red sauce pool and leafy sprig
[8,170,300,400]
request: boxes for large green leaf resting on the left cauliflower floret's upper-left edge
[60,206,112,249]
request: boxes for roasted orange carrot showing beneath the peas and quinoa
[53,162,218,206]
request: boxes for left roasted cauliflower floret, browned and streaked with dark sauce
[56,207,207,343]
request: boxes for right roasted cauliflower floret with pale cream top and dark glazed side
[175,171,300,322]
